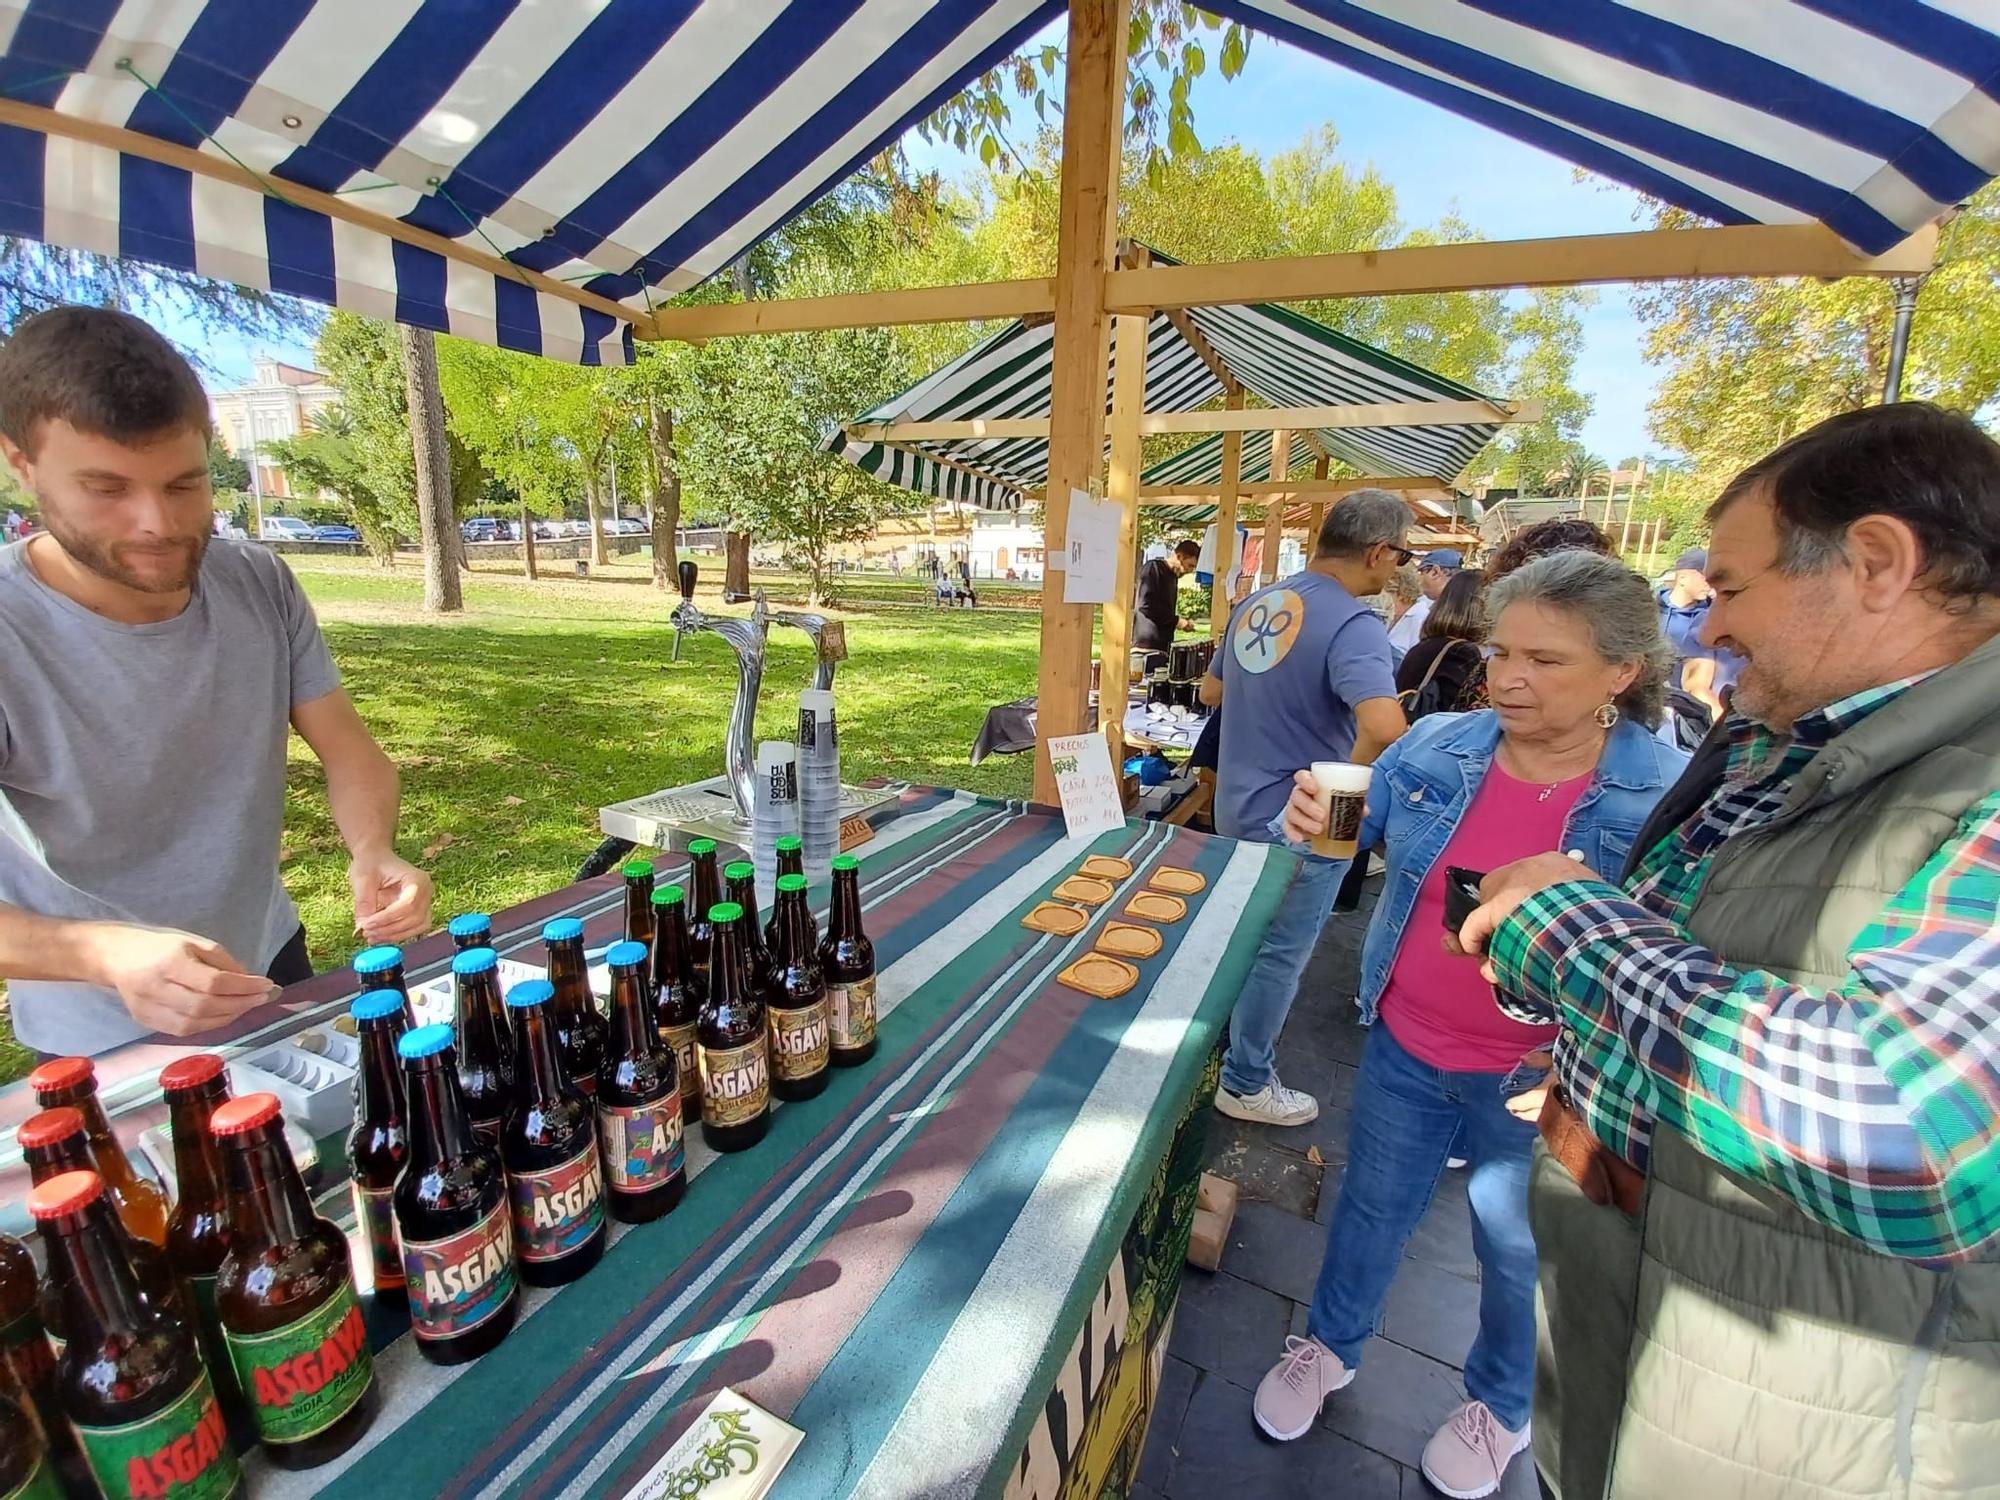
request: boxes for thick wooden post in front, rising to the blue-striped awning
[1034,0,1132,804]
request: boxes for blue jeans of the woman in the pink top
[1306,1024,1544,1432]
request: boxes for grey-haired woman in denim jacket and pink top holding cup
[1254,552,1686,1496]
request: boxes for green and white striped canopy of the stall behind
[826,241,1500,510]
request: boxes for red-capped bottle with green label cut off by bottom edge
[28,1172,242,1500]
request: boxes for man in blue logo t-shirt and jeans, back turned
[1202,490,1412,1126]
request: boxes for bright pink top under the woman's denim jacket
[1382,762,1590,1072]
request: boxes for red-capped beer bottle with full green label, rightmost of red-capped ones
[208,1094,378,1468]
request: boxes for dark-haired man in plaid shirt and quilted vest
[1458,404,2000,1500]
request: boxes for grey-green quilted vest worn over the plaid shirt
[1610,640,2000,1500]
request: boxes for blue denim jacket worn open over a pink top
[1360,708,1688,1024]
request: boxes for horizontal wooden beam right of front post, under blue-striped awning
[1104,224,1938,312]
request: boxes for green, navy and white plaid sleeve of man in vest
[1492,792,2000,1262]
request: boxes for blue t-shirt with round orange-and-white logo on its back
[1212,572,1396,842]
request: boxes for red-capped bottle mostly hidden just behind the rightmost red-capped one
[160,1056,254,1446]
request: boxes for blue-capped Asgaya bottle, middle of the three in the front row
[500,980,610,1286]
